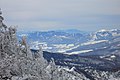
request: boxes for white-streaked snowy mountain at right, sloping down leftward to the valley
[56,29,120,55]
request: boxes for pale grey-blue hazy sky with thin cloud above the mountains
[0,0,120,31]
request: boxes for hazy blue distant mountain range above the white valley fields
[18,31,88,44]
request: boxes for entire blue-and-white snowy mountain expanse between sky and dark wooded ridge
[18,29,120,54]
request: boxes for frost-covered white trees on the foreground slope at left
[0,10,89,80]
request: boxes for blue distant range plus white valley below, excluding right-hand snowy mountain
[18,30,89,52]
